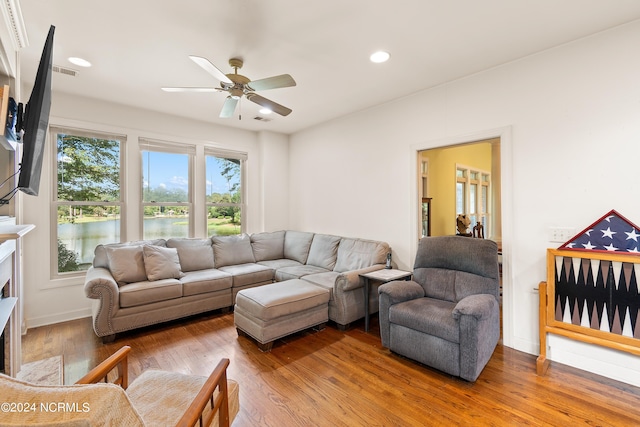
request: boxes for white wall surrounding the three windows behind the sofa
[17,88,288,327]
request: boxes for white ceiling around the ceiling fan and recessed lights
[20,0,640,133]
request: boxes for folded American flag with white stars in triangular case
[558,210,640,255]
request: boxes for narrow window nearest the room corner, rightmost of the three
[205,150,246,236]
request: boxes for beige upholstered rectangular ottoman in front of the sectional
[234,279,329,351]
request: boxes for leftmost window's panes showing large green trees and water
[50,127,125,276]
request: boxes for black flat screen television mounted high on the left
[17,25,55,196]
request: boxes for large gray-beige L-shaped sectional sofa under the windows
[84,230,390,341]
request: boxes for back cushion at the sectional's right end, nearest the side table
[334,238,390,273]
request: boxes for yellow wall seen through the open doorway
[422,141,493,236]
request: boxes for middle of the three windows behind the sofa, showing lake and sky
[140,140,195,239]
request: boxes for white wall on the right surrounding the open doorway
[289,21,640,385]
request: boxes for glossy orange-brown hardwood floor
[23,313,640,427]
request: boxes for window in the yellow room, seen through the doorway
[456,165,491,236]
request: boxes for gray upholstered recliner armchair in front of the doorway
[378,236,500,381]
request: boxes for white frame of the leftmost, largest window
[48,125,127,280]
